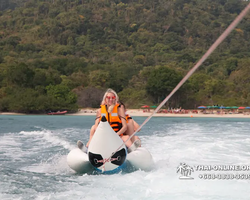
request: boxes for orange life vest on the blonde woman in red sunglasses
[100,103,122,132]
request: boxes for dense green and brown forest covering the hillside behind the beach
[0,0,250,113]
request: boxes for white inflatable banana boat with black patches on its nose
[67,117,154,173]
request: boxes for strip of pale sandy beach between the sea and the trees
[68,108,250,118]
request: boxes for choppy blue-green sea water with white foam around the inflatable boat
[0,115,250,200]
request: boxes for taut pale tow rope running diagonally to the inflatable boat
[104,3,250,168]
